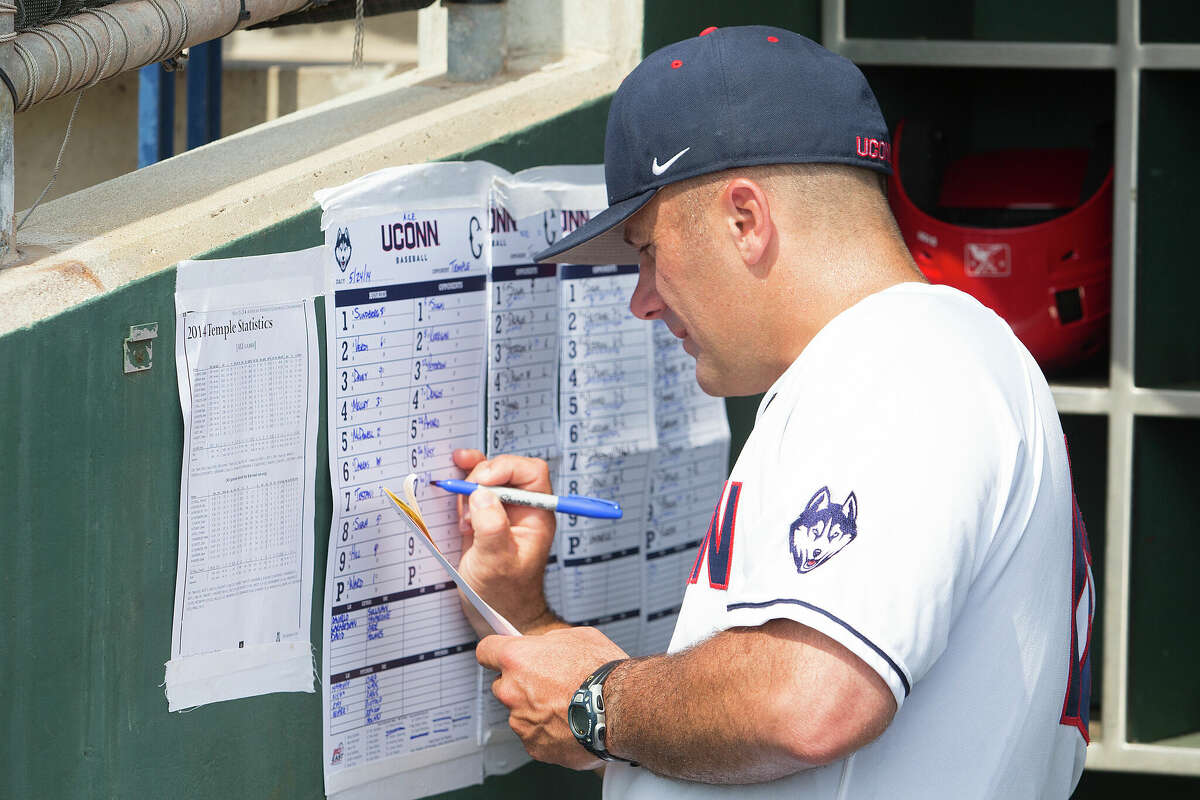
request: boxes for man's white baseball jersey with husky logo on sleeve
[605,283,1094,800]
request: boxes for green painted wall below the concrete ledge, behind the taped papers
[0,102,607,798]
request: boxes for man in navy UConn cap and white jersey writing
[455,28,1094,799]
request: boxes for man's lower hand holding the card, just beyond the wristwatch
[475,627,626,770]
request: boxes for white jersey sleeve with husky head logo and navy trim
[724,316,1022,706]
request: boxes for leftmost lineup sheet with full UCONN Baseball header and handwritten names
[325,210,487,788]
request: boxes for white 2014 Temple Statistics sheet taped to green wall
[166,248,320,711]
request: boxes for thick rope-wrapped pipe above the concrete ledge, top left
[9,0,308,112]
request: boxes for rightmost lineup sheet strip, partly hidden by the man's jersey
[641,320,730,655]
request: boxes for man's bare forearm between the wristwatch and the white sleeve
[604,620,895,783]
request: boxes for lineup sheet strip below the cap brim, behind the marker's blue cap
[556,260,655,652]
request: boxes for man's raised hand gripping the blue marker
[454,450,557,636]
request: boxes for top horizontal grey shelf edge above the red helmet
[838,38,1117,70]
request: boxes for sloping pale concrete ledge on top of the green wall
[0,1,641,333]
